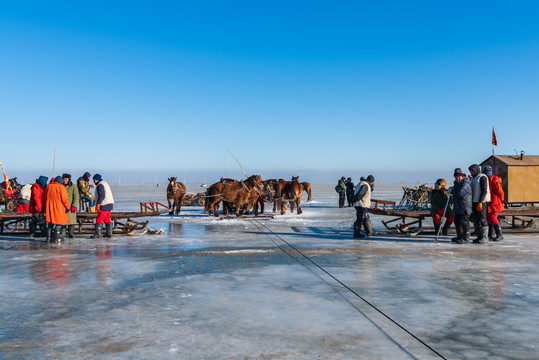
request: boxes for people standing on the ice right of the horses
[335,164,505,244]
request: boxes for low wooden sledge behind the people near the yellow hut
[368,199,539,235]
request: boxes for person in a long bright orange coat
[45,176,71,242]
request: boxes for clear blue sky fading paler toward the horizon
[0,1,539,182]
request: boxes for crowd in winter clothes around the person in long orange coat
[17,172,114,242]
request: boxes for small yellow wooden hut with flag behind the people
[481,153,539,204]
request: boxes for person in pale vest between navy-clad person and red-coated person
[468,164,490,244]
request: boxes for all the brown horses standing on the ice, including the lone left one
[167,175,312,216]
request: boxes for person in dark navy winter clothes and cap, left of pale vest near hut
[451,168,472,244]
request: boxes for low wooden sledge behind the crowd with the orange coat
[0,201,170,235]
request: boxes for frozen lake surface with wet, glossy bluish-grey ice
[0,185,539,359]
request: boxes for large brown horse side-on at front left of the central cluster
[205,175,262,216]
